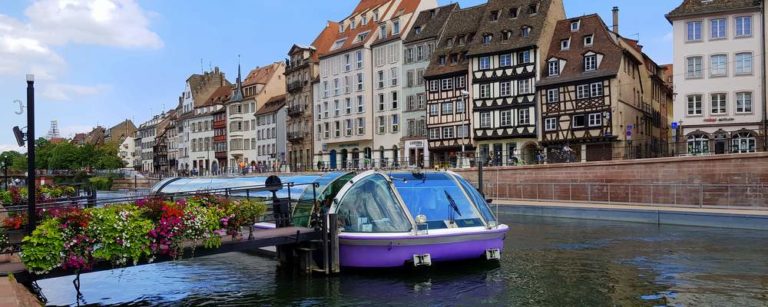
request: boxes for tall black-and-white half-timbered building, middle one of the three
[469,0,565,165]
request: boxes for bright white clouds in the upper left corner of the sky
[0,0,163,90]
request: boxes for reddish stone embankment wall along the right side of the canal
[456,153,768,208]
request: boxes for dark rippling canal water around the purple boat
[33,214,768,306]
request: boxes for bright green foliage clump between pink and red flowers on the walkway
[88,205,153,265]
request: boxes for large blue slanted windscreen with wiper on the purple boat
[392,173,484,229]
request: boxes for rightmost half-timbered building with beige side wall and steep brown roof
[538,9,672,162]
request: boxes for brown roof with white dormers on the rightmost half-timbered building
[537,14,628,86]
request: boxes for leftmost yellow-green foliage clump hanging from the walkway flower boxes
[21,219,64,274]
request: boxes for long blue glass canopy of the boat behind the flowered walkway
[151,176,321,199]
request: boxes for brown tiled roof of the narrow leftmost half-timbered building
[424,4,486,77]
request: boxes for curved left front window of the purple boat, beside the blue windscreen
[336,174,411,232]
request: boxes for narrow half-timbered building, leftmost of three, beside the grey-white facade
[424,5,486,167]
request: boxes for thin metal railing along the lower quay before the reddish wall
[475,182,768,210]
